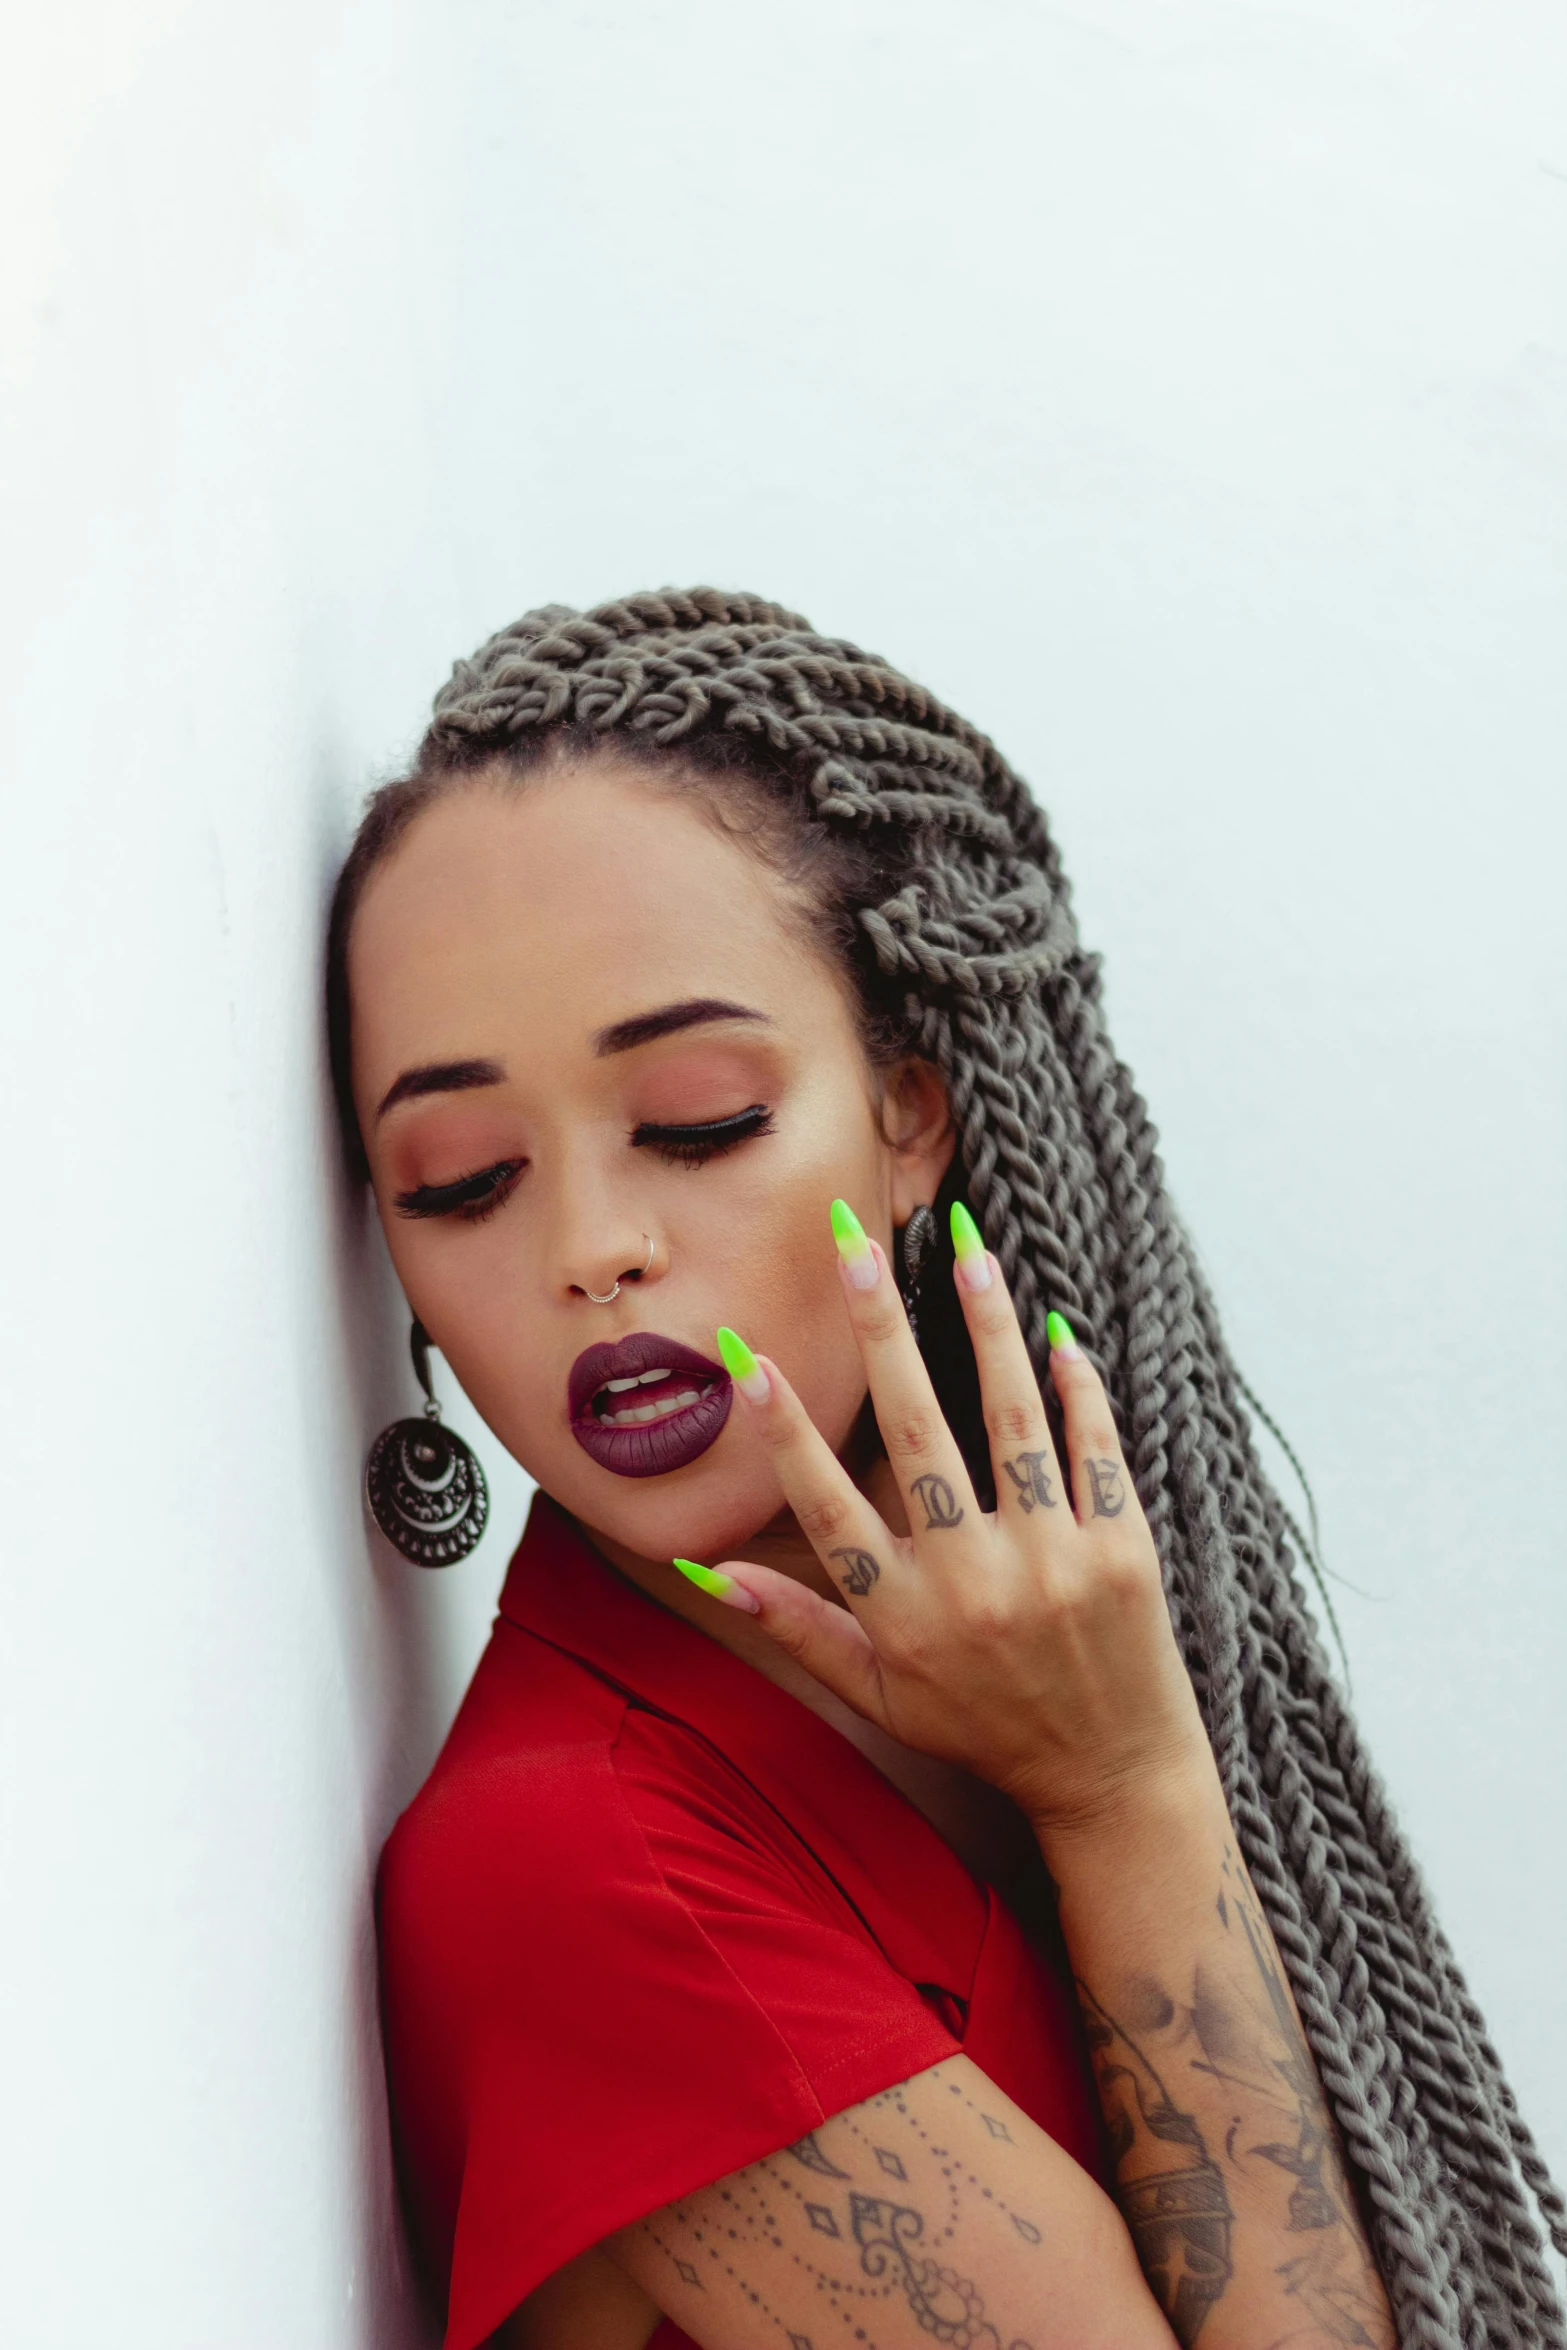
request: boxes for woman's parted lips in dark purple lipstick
[566,1330,735,1476]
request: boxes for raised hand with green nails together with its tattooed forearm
[681,1208,1395,2350]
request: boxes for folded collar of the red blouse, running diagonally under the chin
[500,1492,989,1998]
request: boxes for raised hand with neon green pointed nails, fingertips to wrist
[693,1203,1215,1838]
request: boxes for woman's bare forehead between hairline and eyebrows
[348,768,848,1067]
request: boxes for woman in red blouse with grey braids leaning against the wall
[329,592,1567,2350]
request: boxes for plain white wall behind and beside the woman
[0,0,1567,2350]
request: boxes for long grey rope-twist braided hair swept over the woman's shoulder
[329,588,1567,2350]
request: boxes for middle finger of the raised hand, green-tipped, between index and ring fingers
[832,1199,980,1558]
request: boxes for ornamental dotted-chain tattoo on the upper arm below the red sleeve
[641,2068,1043,2350]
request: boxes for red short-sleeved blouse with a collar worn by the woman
[378,1495,1099,2350]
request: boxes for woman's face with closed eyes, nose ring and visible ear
[348,764,951,1558]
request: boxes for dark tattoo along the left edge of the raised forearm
[1078,1983,1233,2350]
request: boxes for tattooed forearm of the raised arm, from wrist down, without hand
[1038,1770,1395,2350]
